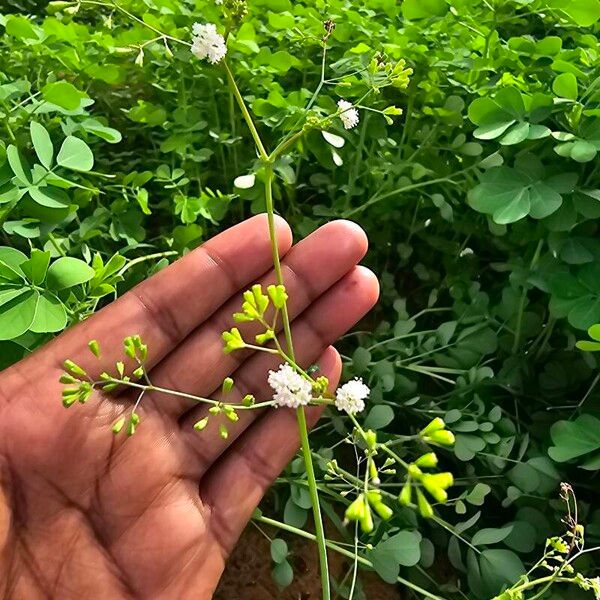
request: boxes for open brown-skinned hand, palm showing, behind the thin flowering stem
[0,215,378,600]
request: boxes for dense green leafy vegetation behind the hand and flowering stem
[0,0,600,599]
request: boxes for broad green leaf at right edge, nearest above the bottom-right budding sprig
[548,414,600,462]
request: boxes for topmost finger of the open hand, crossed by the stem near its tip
[22,215,292,378]
